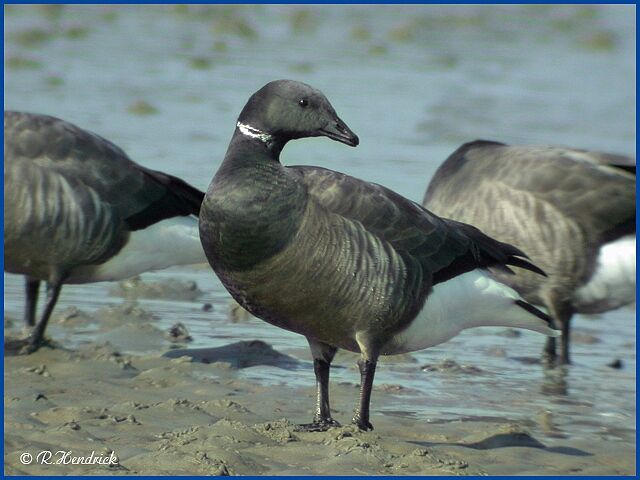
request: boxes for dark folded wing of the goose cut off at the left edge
[4,112,204,230]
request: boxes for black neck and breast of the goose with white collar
[201,128,306,270]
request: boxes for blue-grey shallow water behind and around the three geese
[5,5,636,450]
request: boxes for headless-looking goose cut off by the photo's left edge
[4,112,206,351]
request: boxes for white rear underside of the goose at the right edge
[574,235,636,313]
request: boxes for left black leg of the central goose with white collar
[297,339,340,432]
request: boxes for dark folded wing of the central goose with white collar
[291,166,542,284]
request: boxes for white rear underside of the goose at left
[68,217,207,283]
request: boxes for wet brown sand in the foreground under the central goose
[4,303,635,475]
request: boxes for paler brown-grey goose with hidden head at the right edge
[423,140,636,364]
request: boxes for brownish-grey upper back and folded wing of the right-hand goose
[423,141,635,244]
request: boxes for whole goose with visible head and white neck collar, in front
[200,80,555,430]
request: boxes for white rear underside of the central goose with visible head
[383,270,560,354]
